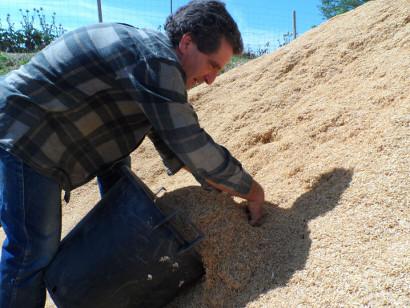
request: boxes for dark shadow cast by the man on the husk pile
[157,168,353,307]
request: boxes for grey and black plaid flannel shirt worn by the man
[0,23,252,194]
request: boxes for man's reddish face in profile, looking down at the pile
[177,33,233,90]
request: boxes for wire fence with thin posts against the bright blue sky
[0,0,321,52]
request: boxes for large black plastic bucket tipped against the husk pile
[45,168,204,308]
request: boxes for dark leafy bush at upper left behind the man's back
[0,8,65,52]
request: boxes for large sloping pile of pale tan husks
[0,0,410,307]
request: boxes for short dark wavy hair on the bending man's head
[164,0,243,55]
